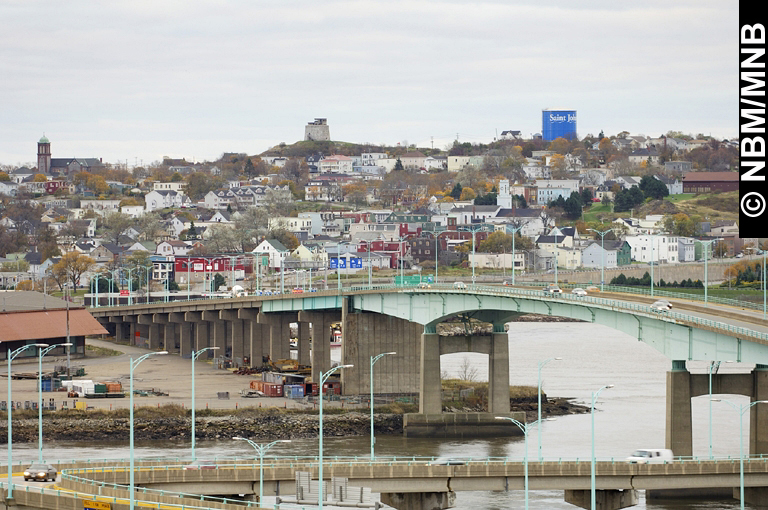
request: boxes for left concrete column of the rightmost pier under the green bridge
[665,360,693,456]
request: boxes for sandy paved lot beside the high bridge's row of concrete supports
[0,339,320,409]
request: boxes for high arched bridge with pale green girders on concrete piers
[90,285,768,456]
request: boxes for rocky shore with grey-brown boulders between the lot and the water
[0,398,589,442]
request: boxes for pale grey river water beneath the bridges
[9,323,753,510]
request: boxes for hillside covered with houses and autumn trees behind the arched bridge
[0,130,764,292]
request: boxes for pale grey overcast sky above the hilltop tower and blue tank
[0,0,738,166]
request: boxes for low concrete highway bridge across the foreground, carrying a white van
[3,458,768,510]
